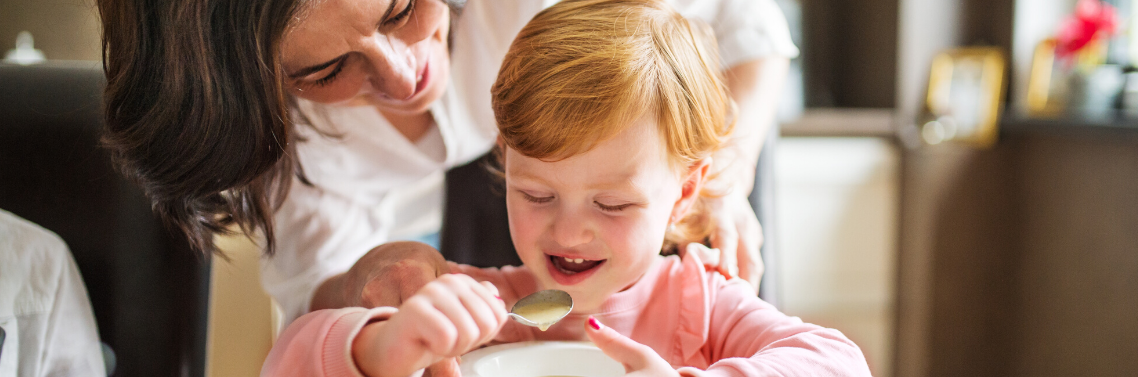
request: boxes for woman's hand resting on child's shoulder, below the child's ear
[679,195,764,292]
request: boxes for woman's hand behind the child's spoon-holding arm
[311,241,450,310]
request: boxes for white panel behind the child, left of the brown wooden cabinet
[773,138,899,376]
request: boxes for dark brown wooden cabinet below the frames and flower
[897,122,1138,376]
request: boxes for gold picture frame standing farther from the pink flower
[920,47,1007,148]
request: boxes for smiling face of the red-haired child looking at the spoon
[505,117,707,312]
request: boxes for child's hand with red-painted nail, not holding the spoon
[585,317,679,377]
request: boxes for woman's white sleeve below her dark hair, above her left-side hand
[261,179,391,326]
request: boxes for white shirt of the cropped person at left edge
[0,210,107,377]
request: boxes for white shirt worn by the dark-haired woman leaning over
[262,0,798,323]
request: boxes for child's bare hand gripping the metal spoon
[352,274,506,377]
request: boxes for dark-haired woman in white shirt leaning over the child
[99,0,797,321]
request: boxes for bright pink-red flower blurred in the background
[1055,0,1119,58]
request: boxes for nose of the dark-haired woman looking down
[365,34,419,99]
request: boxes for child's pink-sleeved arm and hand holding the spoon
[261,274,506,377]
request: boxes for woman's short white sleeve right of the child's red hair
[673,0,798,67]
